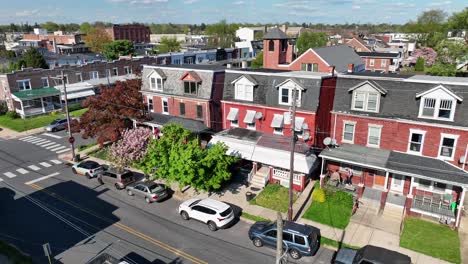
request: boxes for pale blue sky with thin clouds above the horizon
[0,0,468,24]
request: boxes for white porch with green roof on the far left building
[12,87,62,118]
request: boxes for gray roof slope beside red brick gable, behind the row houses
[313,45,364,72]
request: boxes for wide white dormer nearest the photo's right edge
[416,85,462,121]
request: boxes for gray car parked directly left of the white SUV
[127,182,168,203]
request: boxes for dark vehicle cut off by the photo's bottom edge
[333,245,411,264]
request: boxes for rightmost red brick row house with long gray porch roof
[319,74,468,226]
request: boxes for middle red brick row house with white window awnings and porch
[211,68,336,190]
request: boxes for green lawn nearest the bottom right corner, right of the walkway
[400,218,461,263]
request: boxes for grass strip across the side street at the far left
[0,108,87,132]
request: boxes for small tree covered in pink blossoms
[109,127,152,170]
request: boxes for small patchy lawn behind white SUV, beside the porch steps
[250,184,297,213]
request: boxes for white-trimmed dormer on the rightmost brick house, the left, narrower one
[348,81,387,113]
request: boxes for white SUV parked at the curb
[179,198,234,231]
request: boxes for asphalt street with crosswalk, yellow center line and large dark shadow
[0,136,333,264]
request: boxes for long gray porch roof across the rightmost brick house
[319,144,468,185]
